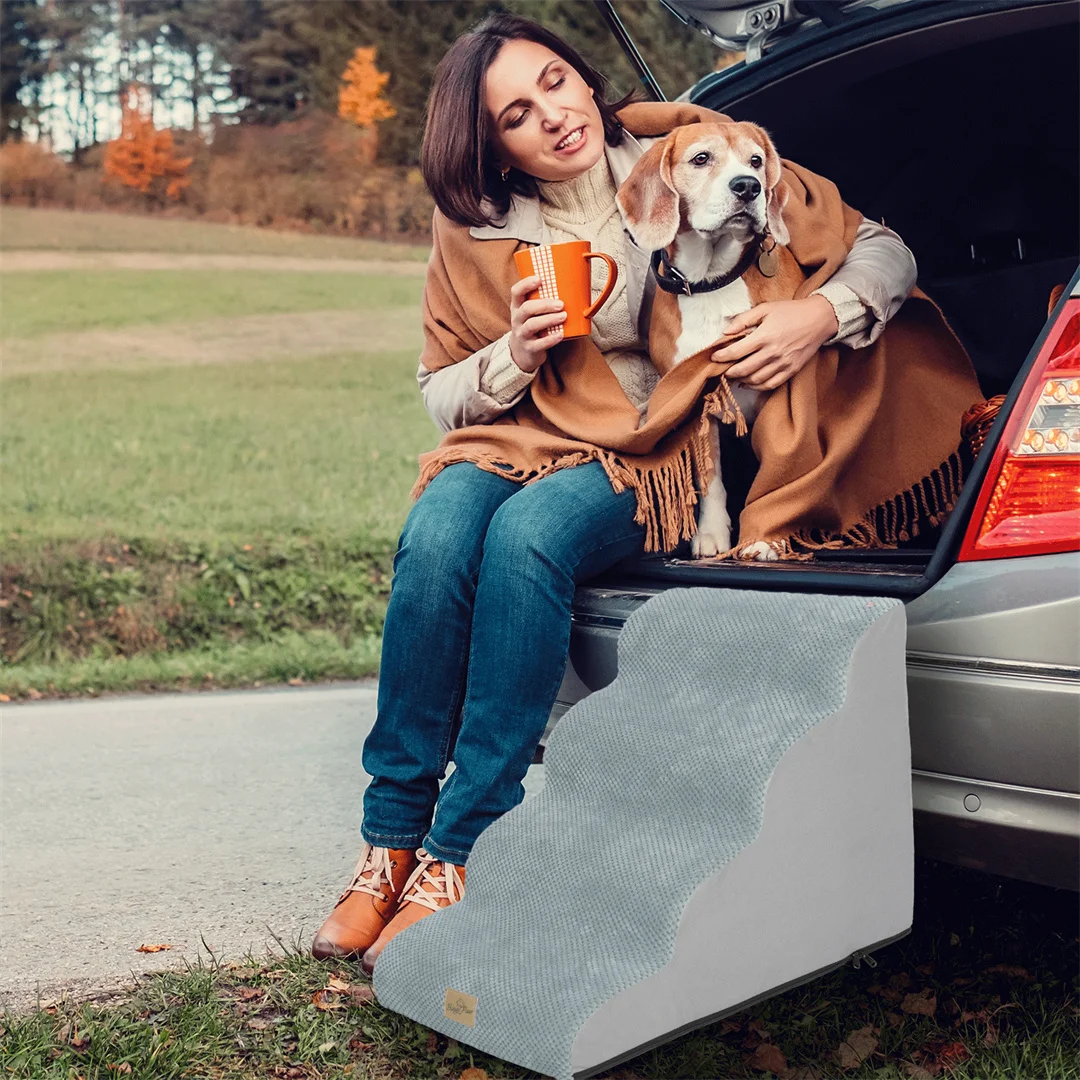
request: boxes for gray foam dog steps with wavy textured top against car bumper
[374,589,914,1080]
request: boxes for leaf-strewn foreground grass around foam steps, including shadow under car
[0,860,1080,1080]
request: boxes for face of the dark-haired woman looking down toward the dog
[484,40,604,180]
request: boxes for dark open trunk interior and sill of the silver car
[616,2,1080,596]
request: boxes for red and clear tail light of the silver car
[959,299,1080,562]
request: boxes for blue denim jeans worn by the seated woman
[361,461,645,866]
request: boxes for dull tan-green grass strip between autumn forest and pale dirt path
[0,206,430,262]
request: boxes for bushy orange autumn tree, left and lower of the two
[104,83,193,203]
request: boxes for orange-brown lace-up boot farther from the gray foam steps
[311,842,417,960]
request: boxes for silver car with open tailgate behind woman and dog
[537,0,1080,889]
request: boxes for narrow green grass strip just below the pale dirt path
[0,270,423,338]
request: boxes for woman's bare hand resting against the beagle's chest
[713,294,838,390]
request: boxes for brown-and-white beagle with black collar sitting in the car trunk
[616,122,801,561]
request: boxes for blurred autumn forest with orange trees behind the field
[0,0,735,241]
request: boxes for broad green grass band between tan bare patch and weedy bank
[0,353,437,550]
